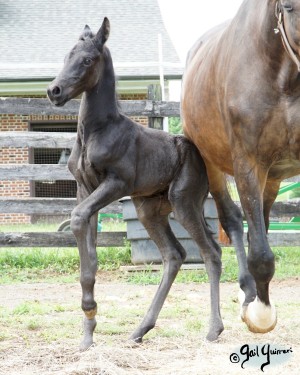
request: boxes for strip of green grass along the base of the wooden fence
[0,241,300,285]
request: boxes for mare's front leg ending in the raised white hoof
[234,162,276,333]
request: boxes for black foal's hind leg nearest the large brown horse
[169,155,224,341]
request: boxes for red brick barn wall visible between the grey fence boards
[0,94,148,224]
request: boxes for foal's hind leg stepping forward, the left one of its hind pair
[131,196,186,342]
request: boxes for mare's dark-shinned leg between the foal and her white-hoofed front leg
[206,162,256,306]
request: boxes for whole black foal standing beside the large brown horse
[48,18,224,349]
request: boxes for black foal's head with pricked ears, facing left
[47,17,110,106]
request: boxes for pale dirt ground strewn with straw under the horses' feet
[0,278,300,375]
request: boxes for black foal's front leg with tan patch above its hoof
[71,180,126,350]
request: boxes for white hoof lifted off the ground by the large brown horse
[241,297,277,333]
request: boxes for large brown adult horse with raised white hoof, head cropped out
[182,0,300,333]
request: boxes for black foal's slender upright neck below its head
[79,47,120,130]
